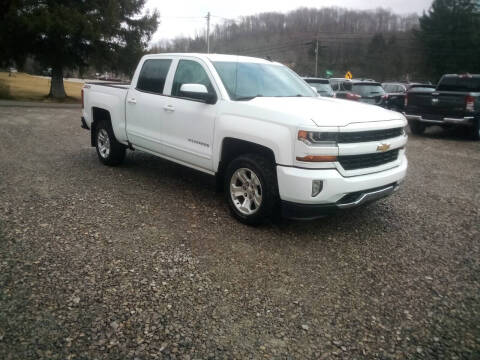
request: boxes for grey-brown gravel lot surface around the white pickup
[0,107,480,359]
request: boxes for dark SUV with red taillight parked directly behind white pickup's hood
[330,79,387,107]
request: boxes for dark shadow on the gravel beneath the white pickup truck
[93,152,390,234]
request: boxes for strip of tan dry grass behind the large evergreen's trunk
[0,72,83,103]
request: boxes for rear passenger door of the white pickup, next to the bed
[126,58,173,154]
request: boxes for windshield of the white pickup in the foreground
[213,61,315,100]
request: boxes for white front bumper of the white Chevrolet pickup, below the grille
[277,155,408,219]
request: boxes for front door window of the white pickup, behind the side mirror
[172,60,215,97]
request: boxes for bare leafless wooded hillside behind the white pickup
[152,7,423,80]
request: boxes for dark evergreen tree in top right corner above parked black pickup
[417,0,480,78]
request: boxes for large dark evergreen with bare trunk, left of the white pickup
[4,0,158,98]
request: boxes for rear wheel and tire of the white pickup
[95,120,126,166]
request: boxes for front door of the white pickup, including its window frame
[162,58,219,171]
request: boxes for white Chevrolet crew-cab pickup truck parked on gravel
[81,54,407,224]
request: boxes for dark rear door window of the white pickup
[137,59,172,94]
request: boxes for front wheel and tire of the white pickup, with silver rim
[224,154,279,225]
